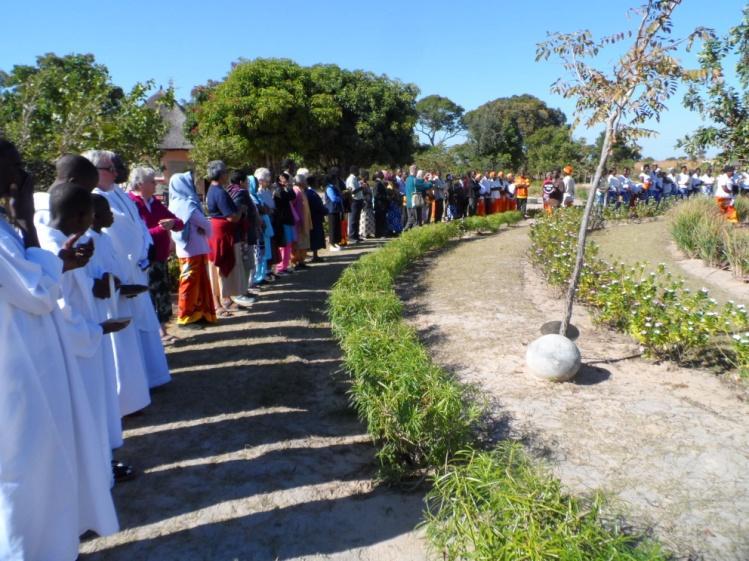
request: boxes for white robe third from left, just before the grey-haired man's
[86,230,151,417]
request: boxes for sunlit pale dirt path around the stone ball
[401,223,749,561]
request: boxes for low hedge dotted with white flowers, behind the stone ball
[531,206,749,375]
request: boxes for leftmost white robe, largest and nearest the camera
[0,219,117,561]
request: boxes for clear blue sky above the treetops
[0,0,745,158]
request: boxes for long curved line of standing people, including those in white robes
[5,129,749,561]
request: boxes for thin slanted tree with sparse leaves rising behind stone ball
[536,0,712,335]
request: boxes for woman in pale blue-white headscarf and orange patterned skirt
[169,171,216,326]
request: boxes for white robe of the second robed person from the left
[37,226,122,462]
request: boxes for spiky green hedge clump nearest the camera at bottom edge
[426,442,667,561]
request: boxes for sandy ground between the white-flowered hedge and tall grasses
[591,217,749,304]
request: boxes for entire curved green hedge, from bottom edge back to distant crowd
[329,212,666,561]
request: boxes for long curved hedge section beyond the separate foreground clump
[328,212,520,480]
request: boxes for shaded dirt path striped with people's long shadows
[80,242,426,561]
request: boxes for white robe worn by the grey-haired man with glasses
[94,185,172,388]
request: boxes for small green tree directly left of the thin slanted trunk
[526,126,590,176]
